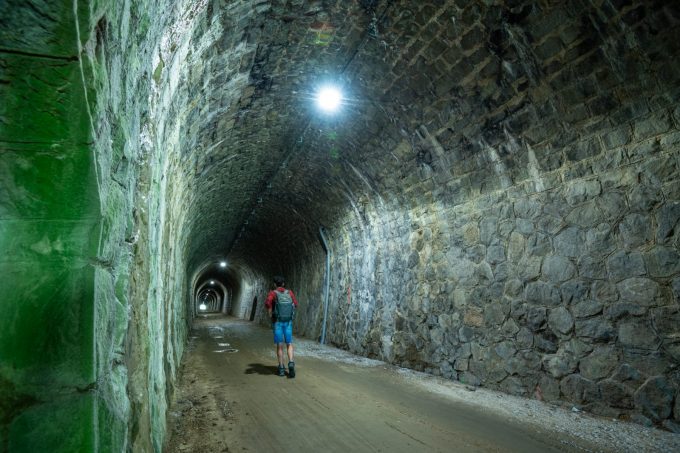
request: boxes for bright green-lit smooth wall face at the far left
[0,1,101,452]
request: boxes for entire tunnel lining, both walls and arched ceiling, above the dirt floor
[0,0,680,452]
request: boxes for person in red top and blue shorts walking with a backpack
[264,275,298,378]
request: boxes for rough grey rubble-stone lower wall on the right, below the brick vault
[314,134,680,423]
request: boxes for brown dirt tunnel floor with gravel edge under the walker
[166,317,680,453]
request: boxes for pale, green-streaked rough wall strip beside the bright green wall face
[86,1,215,451]
